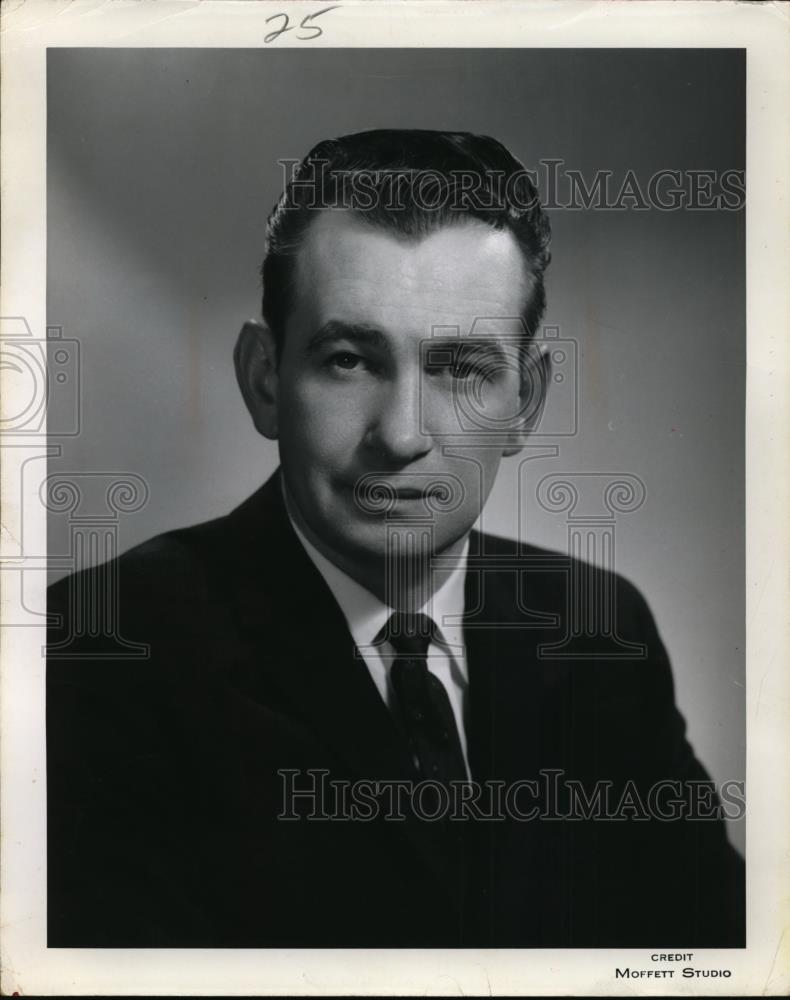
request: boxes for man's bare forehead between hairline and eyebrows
[297,210,529,326]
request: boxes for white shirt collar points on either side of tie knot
[283,490,469,651]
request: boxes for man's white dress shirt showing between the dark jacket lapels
[288,513,470,776]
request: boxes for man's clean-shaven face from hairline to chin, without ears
[266,212,528,569]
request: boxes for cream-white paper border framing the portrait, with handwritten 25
[0,0,790,996]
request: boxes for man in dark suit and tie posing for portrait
[47,131,744,948]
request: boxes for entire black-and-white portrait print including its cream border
[2,3,786,995]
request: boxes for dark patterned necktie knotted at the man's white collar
[384,612,467,785]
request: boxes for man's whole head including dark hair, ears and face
[236,130,549,590]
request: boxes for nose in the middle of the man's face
[367,373,431,465]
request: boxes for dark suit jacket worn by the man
[47,477,744,948]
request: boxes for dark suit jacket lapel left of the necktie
[216,475,468,899]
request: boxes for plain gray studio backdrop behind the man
[47,48,745,843]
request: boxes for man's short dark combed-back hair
[261,129,551,347]
